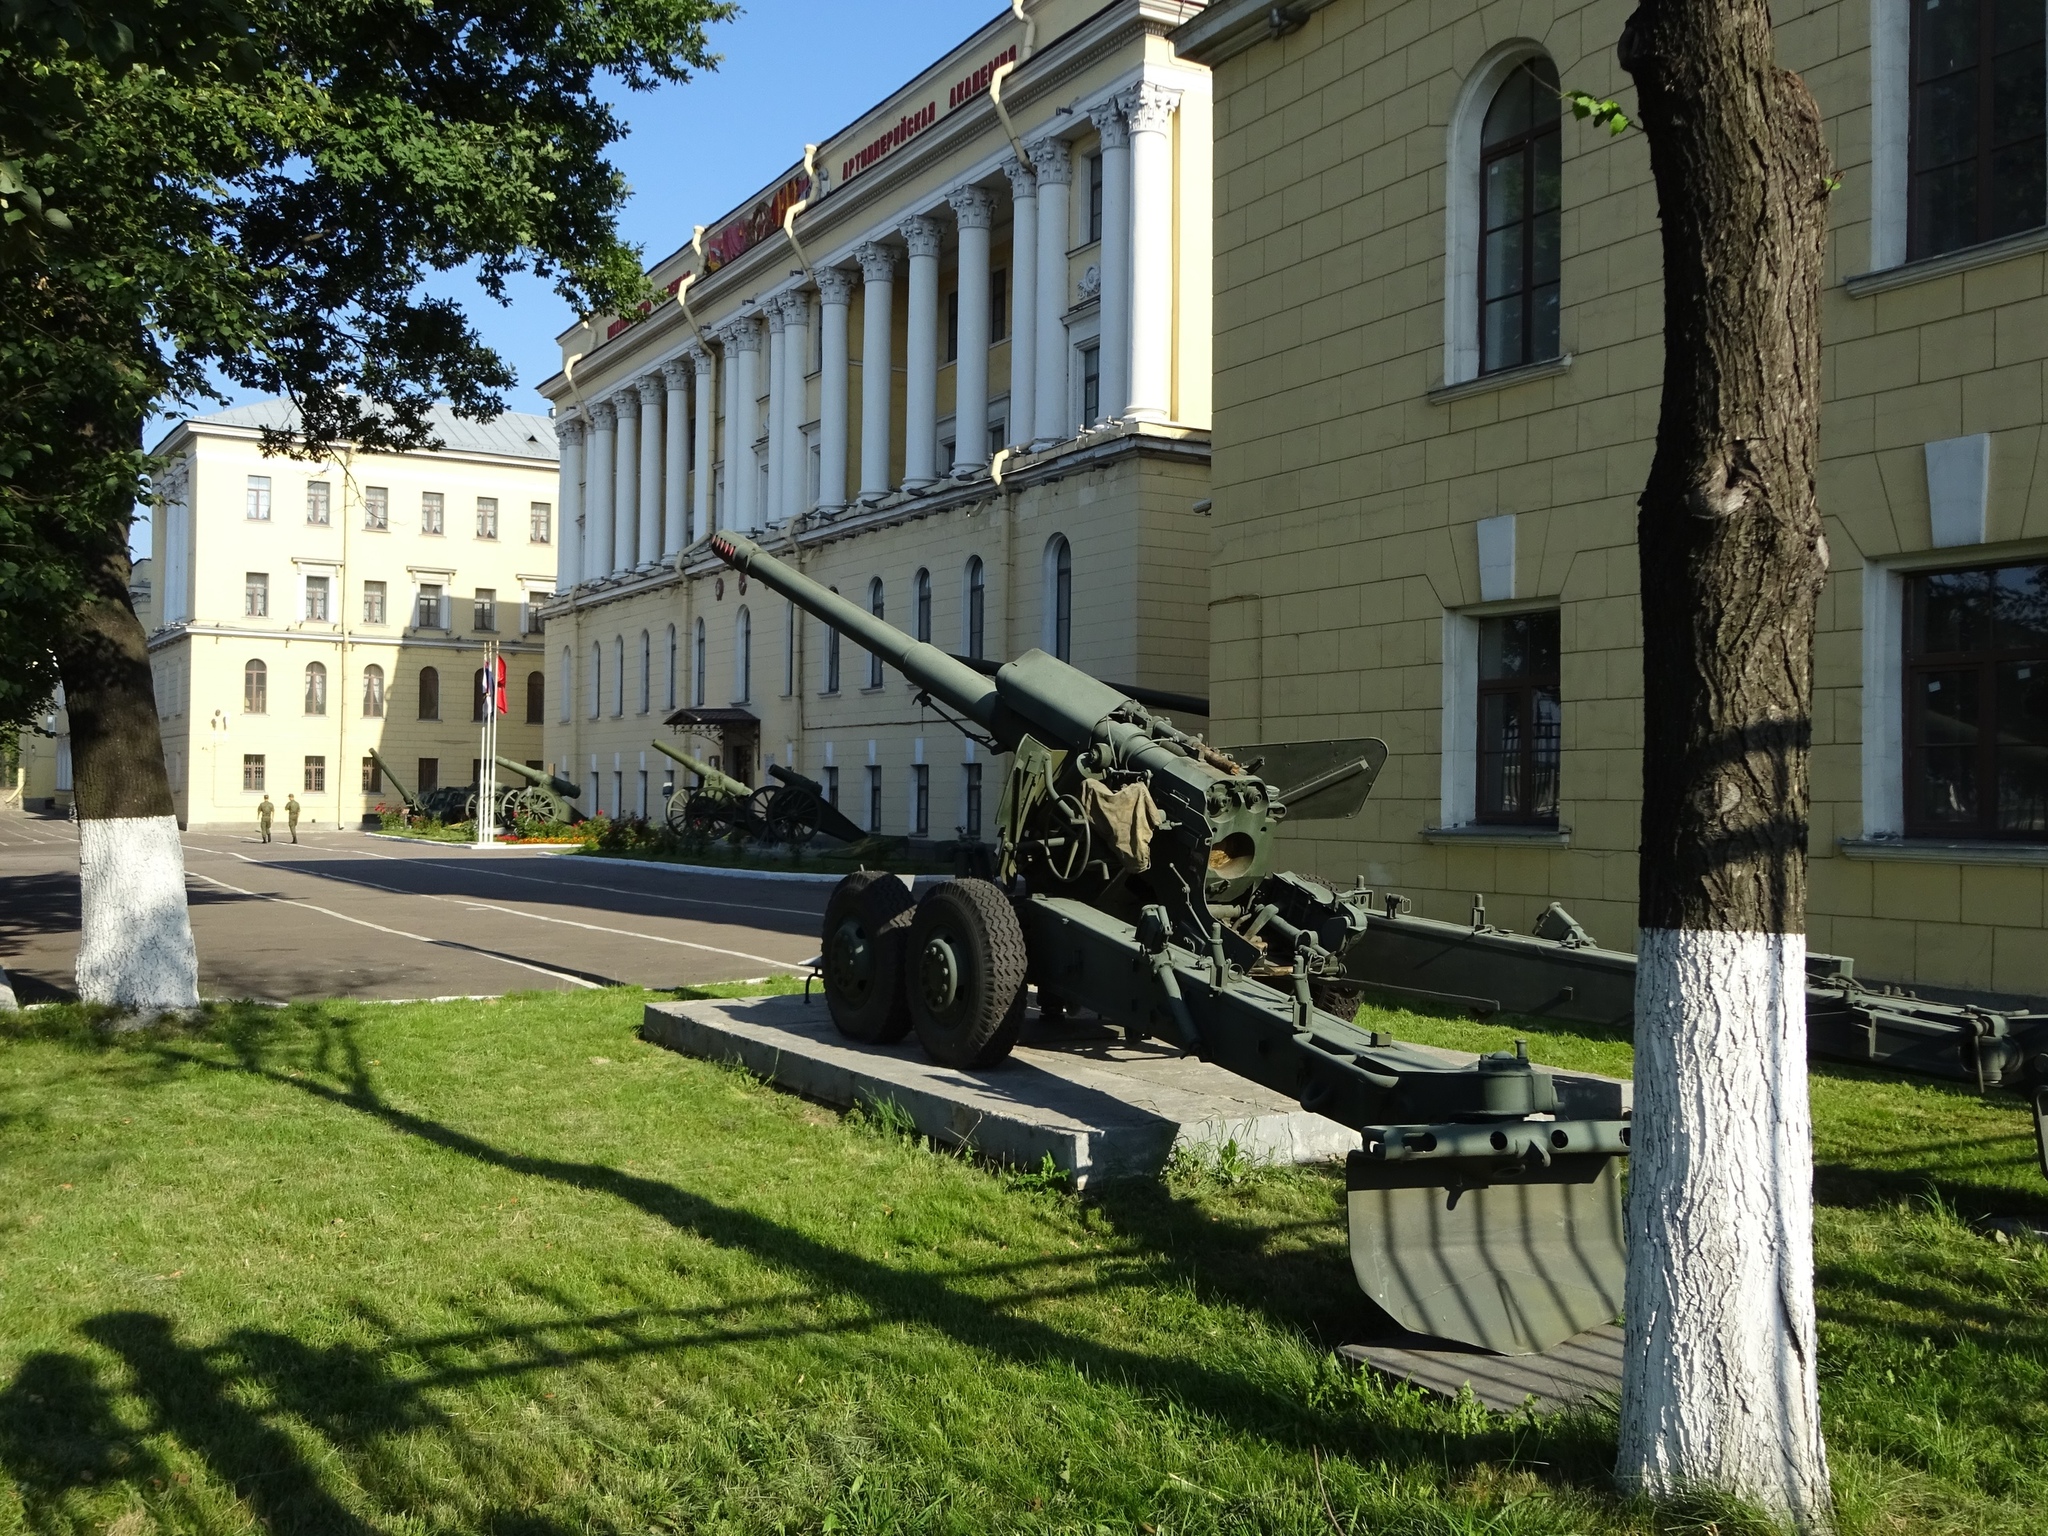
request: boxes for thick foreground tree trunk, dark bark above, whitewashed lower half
[1616,0,1831,1530]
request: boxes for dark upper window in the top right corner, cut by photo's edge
[1907,0,2048,258]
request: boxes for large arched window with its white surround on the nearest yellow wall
[1444,39,1563,385]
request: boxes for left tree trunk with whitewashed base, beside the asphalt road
[57,536,199,1012]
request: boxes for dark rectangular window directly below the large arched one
[1477,610,1563,827]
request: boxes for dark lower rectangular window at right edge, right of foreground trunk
[1905,563,2048,842]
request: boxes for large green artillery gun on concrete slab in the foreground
[711,532,1630,1352]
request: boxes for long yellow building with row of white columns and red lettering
[541,0,1210,840]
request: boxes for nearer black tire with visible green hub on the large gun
[903,881,1028,1067]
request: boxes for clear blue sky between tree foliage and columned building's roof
[131,0,1008,553]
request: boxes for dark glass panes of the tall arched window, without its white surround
[1479,57,1563,373]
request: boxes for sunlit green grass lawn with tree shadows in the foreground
[0,991,2048,1536]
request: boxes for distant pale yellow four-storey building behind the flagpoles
[145,401,559,827]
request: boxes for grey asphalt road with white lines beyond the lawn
[0,815,831,1001]
